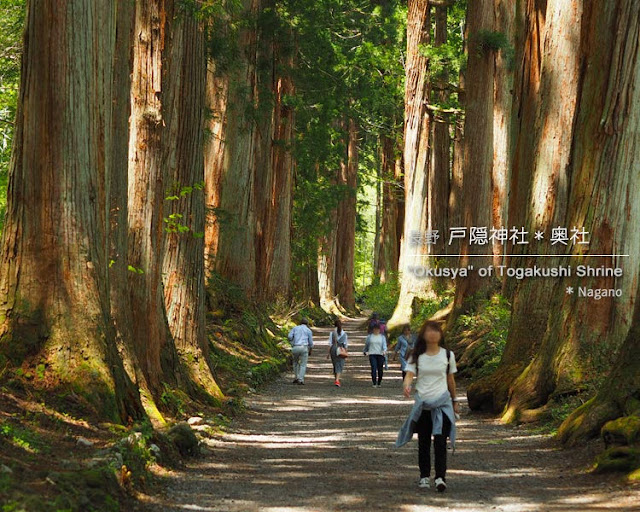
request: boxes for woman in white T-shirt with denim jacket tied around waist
[396,320,458,492]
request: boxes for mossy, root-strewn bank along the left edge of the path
[0,276,304,512]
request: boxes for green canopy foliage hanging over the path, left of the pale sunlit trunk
[278,0,406,287]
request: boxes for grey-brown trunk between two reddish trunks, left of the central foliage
[215,0,264,296]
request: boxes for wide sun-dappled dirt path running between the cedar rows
[154,320,640,512]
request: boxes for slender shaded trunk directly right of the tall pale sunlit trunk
[427,5,455,284]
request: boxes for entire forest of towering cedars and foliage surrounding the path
[0,0,640,508]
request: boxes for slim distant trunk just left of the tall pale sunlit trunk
[375,135,401,283]
